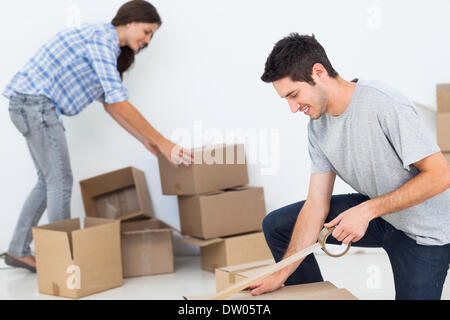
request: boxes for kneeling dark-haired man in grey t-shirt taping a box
[249,34,450,299]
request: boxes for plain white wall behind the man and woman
[0,0,450,254]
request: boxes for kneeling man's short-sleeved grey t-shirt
[308,80,450,245]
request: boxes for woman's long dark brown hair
[111,0,162,78]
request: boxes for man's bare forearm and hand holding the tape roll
[325,152,450,243]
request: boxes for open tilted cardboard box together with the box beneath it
[80,167,174,278]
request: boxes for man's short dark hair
[261,33,338,85]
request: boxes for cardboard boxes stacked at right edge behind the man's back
[436,84,450,165]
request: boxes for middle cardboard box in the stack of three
[178,187,266,239]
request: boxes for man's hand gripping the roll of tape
[324,202,373,244]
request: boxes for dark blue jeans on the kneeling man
[263,194,450,300]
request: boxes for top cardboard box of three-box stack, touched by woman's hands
[158,144,248,195]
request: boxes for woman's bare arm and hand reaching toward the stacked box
[103,101,193,165]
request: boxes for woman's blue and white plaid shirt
[3,23,128,117]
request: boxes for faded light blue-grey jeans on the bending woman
[8,94,73,257]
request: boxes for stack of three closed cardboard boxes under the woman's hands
[158,144,272,272]
